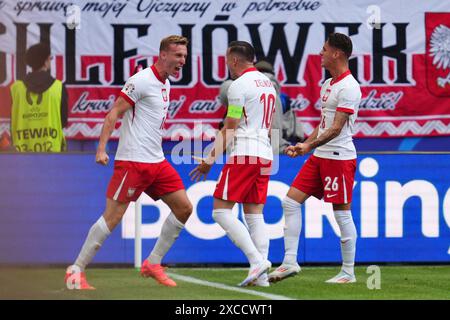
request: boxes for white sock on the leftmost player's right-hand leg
[147,212,184,264]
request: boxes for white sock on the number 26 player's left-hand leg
[281,196,302,265]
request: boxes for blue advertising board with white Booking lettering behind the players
[0,154,450,264]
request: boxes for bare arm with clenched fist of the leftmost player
[95,96,133,166]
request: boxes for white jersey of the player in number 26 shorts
[314,71,361,160]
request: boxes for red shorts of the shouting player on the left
[106,159,184,202]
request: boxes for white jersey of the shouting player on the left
[116,66,170,163]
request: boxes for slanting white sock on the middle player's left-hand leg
[213,209,263,265]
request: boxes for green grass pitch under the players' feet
[0,265,450,300]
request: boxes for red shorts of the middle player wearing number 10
[214,156,272,204]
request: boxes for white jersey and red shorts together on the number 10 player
[214,67,276,203]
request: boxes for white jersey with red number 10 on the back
[228,68,276,160]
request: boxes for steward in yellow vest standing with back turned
[11,43,67,152]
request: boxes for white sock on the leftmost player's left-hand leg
[75,216,111,272]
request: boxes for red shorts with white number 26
[292,155,356,204]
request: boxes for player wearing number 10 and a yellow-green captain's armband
[190,41,276,286]
